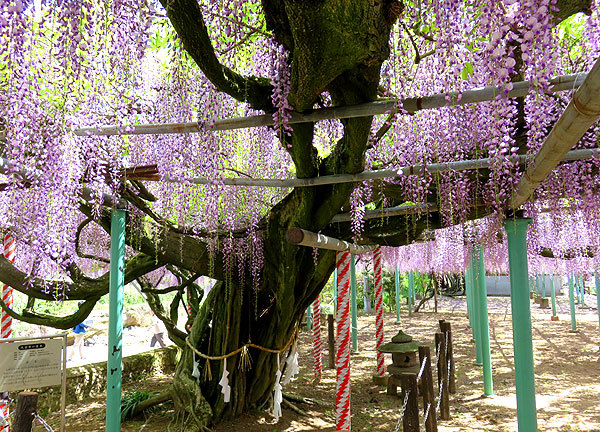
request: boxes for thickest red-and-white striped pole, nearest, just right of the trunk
[335,252,351,431]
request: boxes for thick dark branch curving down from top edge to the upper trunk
[160,0,273,111]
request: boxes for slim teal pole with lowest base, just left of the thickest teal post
[476,245,494,396]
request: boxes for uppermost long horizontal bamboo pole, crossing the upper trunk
[72,74,586,139]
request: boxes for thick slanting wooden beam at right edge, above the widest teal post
[509,59,600,210]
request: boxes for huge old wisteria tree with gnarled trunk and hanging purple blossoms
[0,0,600,429]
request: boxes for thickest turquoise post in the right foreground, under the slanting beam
[504,219,537,432]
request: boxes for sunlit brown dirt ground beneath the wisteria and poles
[34,296,600,432]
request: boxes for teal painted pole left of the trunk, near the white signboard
[106,209,126,432]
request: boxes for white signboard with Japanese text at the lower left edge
[0,339,63,391]
